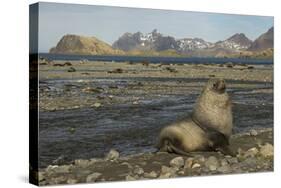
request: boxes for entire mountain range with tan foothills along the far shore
[49,27,274,59]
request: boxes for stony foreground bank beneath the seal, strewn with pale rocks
[34,128,274,185]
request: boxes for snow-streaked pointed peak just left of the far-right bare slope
[215,33,252,50]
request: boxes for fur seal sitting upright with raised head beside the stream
[157,78,233,155]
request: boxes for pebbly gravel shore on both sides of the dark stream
[32,61,274,185]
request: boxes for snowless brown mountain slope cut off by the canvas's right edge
[248,27,274,51]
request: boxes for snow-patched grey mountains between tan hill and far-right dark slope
[113,29,252,56]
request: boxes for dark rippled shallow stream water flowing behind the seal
[39,78,273,167]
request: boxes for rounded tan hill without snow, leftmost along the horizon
[50,34,124,55]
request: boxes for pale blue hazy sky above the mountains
[34,2,273,52]
